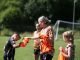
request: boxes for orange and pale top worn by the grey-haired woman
[40,25,54,53]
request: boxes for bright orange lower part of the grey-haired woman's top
[40,35,53,53]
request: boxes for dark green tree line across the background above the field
[0,0,80,32]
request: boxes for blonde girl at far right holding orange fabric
[58,31,74,60]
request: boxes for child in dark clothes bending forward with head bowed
[4,33,20,60]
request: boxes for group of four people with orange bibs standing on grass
[4,16,74,60]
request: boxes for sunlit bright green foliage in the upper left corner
[0,0,21,21]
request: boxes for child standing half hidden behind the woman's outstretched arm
[33,24,41,60]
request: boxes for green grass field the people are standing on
[0,34,80,60]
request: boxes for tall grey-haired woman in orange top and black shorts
[38,16,54,60]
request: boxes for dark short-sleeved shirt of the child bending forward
[4,37,15,54]
